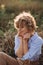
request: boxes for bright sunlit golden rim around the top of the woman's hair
[14,11,37,29]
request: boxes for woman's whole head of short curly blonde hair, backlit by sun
[14,12,37,30]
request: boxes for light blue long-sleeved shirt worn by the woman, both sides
[14,32,43,61]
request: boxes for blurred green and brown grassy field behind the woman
[0,0,43,56]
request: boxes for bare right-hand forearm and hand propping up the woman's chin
[23,33,30,55]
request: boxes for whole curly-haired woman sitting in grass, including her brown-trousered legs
[0,12,43,65]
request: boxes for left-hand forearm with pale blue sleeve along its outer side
[15,37,23,57]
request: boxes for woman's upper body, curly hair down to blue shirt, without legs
[14,12,43,61]
